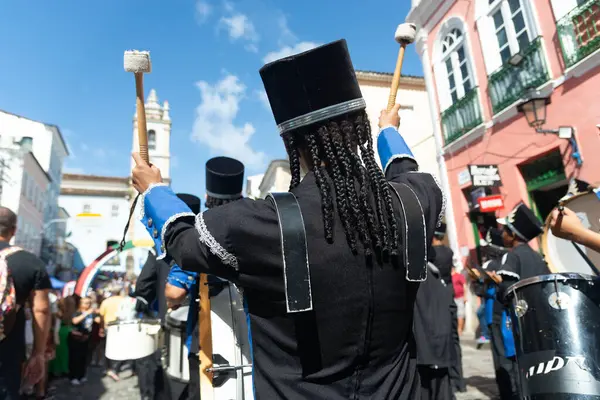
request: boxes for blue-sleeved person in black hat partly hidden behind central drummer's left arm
[165,157,244,400]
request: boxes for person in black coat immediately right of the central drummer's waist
[414,263,456,400]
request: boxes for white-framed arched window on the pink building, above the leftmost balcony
[442,29,474,104]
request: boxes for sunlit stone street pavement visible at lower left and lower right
[49,340,498,400]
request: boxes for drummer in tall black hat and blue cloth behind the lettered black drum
[490,203,550,400]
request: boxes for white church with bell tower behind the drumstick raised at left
[59,89,171,272]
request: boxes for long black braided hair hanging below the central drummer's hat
[282,110,399,260]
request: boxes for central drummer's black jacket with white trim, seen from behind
[157,159,442,400]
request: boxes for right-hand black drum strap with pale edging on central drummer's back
[390,182,429,282]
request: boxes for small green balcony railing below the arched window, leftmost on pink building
[442,87,483,144]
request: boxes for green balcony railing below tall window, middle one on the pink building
[488,37,550,114]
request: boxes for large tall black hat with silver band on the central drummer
[260,39,366,134]
